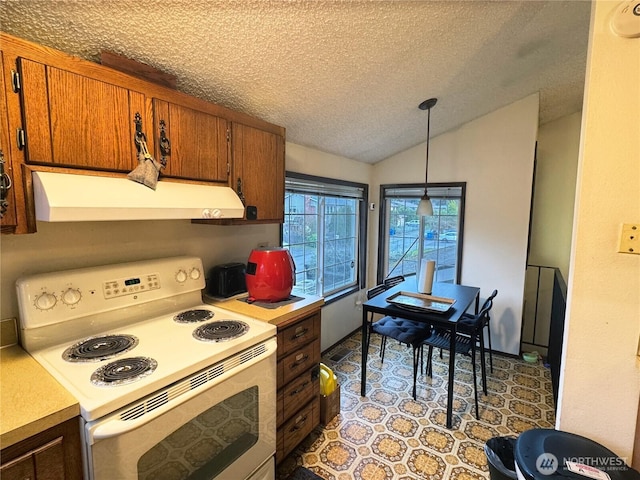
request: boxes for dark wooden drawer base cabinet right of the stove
[276,309,321,463]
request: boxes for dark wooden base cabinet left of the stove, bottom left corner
[0,418,82,480]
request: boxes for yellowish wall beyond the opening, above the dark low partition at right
[529,112,582,281]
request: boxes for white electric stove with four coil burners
[17,257,276,480]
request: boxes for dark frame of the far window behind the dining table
[376,182,467,284]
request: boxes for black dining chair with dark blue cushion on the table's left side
[365,277,431,400]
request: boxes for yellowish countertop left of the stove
[0,345,80,448]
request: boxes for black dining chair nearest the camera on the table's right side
[422,299,493,419]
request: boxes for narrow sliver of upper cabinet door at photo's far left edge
[0,52,17,232]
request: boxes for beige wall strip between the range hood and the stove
[0,220,280,319]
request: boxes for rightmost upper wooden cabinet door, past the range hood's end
[231,123,284,223]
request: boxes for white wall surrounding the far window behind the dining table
[369,94,538,354]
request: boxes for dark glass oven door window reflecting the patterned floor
[138,386,259,480]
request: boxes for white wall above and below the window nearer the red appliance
[285,143,377,350]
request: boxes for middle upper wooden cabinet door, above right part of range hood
[153,99,229,185]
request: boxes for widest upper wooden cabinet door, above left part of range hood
[19,58,145,172]
